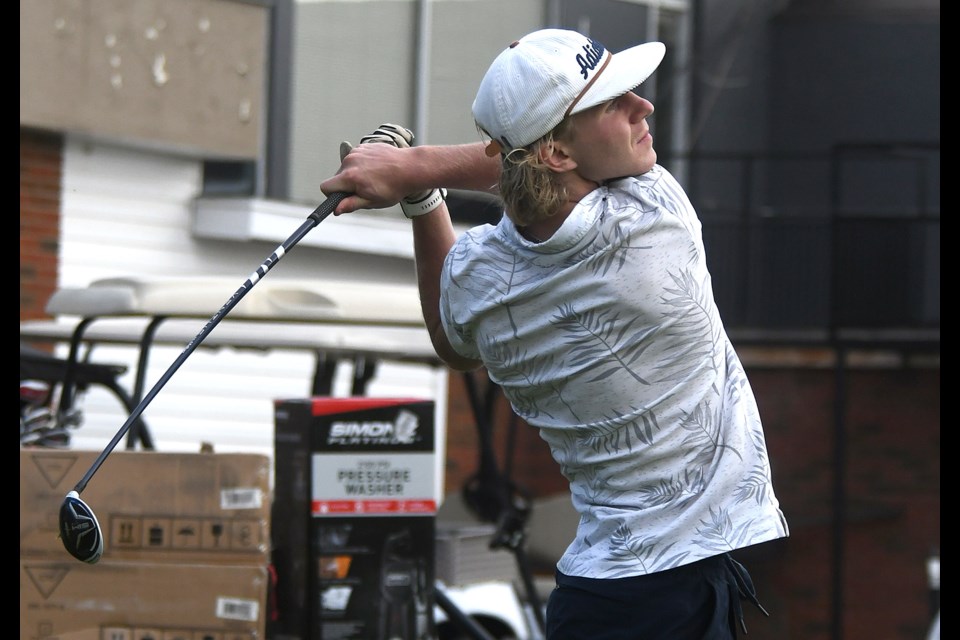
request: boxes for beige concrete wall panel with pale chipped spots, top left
[20,0,269,159]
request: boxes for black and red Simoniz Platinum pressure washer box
[268,398,439,640]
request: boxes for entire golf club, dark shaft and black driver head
[60,193,348,564]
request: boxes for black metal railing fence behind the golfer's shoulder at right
[680,143,940,347]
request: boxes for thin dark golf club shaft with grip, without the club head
[73,193,349,494]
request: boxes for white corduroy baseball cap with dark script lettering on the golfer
[473,29,666,156]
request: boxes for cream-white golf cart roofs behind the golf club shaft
[20,277,440,364]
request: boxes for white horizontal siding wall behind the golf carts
[60,139,446,488]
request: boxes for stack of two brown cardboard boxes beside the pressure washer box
[20,448,271,640]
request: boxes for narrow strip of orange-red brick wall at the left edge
[20,128,62,320]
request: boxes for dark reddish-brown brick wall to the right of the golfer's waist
[748,367,940,640]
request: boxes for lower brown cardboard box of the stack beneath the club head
[20,558,268,640]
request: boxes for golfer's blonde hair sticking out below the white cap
[478,118,571,227]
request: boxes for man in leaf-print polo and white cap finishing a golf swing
[321,29,788,640]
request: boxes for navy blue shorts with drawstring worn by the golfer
[546,554,766,640]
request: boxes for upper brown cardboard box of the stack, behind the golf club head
[20,448,271,567]
